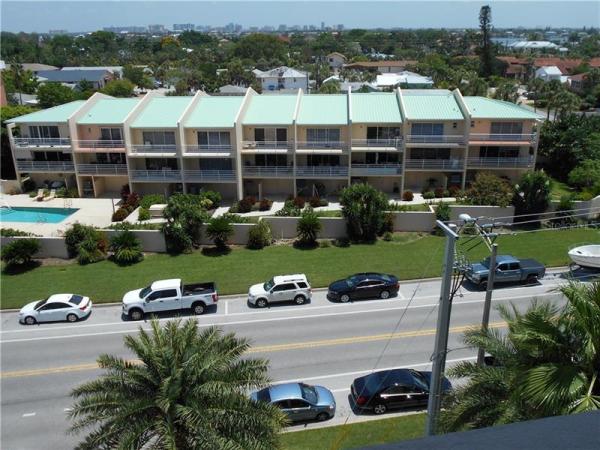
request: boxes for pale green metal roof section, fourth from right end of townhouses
[296,94,348,125]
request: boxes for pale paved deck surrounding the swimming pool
[0,194,121,237]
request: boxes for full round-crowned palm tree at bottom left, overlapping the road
[69,320,286,450]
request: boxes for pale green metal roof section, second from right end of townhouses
[402,89,464,120]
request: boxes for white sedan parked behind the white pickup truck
[19,294,92,325]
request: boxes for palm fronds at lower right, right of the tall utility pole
[440,282,600,431]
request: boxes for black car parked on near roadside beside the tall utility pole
[350,369,452,414]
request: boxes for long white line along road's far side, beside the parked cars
[0,292,559,344]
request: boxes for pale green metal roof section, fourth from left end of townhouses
[184,96,244,128]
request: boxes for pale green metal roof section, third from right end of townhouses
[350,92,402,123]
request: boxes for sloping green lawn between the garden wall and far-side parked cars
[0,229,600,308]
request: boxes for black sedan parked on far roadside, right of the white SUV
[327,273,400,303]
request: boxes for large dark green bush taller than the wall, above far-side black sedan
[340,183,389,241]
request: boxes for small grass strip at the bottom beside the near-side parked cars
[281,414,425,450]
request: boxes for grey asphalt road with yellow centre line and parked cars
[0,271,584,450]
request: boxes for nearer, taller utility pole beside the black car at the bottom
[425,220,458,436]
